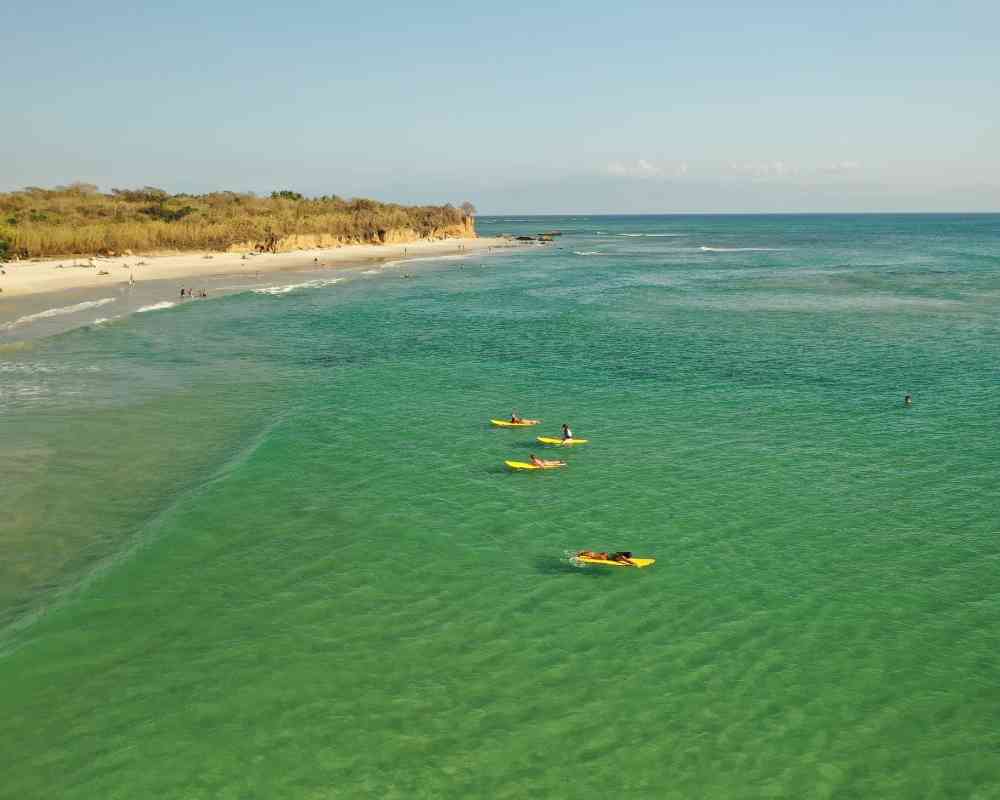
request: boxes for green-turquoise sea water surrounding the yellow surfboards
[0,215,1000,798]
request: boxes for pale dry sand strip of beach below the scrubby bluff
[0,237,512,304]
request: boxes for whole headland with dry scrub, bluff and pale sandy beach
[0,184,512,300]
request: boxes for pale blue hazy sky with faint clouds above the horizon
[0,0,1000,214]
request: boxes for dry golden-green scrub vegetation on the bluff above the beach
[0,183,474,258]
